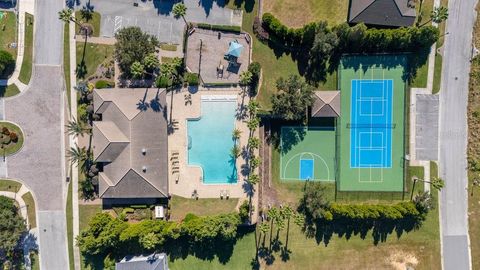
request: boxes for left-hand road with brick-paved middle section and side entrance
[5,0,69,270]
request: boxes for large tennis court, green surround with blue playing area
[337,55,407,192]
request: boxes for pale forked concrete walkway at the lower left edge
[0,182,38,270]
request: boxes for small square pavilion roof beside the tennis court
[311,91,340,117]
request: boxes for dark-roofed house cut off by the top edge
[348,0,416,27]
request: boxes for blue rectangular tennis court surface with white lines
[349,80,395,168]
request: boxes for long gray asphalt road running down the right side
[439,0,477,270]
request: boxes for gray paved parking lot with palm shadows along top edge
[81,0,242,44]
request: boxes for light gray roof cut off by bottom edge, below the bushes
[115,253,168,270]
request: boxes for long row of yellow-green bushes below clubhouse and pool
[77,213,240,257]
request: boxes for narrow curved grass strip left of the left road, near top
[18,13,33,85]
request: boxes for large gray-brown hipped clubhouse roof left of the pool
[92,88,168,199]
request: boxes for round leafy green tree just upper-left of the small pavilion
[272,75,314,120]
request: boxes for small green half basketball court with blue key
[280,126,335,181]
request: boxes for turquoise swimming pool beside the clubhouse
[187,95,237,184]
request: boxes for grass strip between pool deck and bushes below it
[170,196,238,220]
